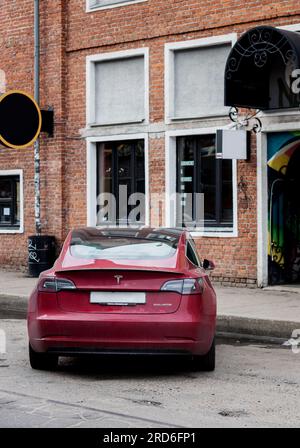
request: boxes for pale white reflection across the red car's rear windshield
[70,236,177,260]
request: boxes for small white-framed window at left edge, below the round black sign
[0,170,24,234]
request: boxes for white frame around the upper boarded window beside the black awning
[165,33,237,124]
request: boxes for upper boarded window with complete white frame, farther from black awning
[87,48,149,127]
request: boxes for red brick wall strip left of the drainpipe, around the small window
[0,0,34,267]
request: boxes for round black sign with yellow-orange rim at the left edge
[0,90,42,149]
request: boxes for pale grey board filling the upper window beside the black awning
[170,44,231,118]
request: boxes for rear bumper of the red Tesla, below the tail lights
[28,312,215,356]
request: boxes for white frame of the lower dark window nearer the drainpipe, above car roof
[86,133,150,224]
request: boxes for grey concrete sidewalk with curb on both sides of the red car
[0,270,300,340]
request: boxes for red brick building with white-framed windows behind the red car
[0,0,300,285]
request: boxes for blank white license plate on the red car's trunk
[90,291,146,305]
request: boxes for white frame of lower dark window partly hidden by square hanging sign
[165,127,238,238]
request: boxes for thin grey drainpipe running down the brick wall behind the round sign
[34,0,41,235]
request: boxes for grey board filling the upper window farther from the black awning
[95,56,145,124]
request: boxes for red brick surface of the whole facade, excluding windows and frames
[0,0,300,284]
